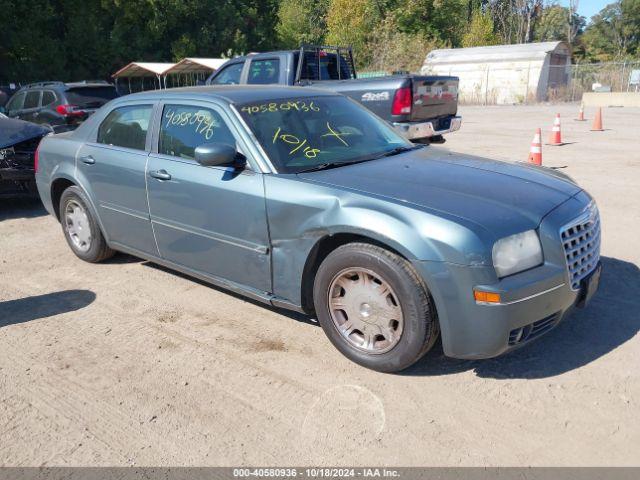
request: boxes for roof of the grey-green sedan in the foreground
[117,85,338,103]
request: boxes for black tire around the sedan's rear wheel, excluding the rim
[59,186,115,263]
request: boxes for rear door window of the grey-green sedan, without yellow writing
[96,105,152,150]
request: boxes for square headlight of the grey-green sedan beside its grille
[492,230,542,278]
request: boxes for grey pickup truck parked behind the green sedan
[207,46,462,143]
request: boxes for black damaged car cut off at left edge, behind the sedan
[0,113,51,197]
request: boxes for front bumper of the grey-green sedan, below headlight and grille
[416,192,600,359]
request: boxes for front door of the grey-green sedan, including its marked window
[147,102,271,292]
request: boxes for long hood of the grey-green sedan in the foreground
[299,147,581,238]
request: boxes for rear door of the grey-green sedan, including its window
[76,104,158,256]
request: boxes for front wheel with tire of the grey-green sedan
[313,243,439,372]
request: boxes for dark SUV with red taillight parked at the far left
[4,81,118,132]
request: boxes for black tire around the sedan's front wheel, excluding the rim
[313,243,440,373]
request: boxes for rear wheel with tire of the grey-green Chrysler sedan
[60,187,115,263]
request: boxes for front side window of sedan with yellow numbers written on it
[158,105,236,160]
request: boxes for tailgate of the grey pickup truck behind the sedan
[409,75,458,122]
